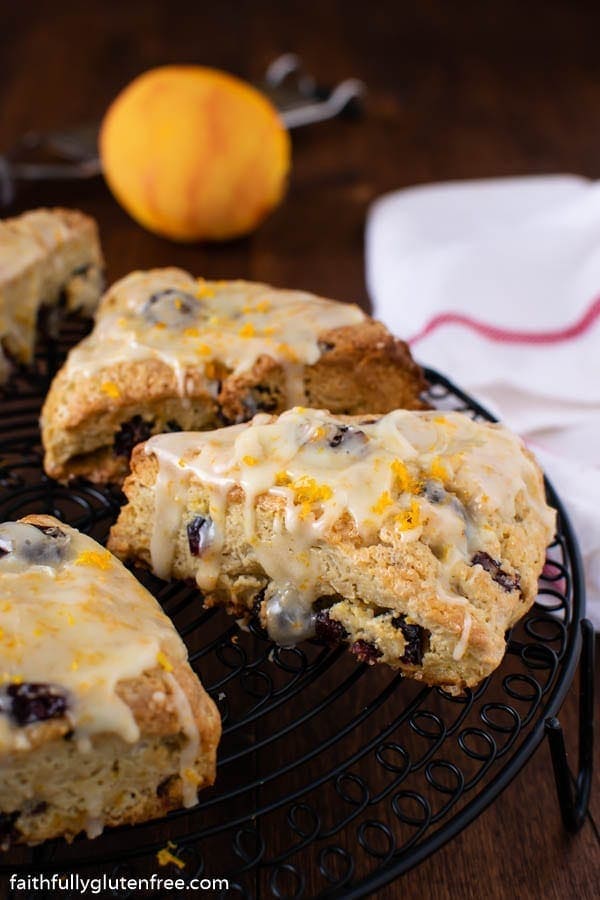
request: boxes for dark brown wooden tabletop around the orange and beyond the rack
[0,0,600,900]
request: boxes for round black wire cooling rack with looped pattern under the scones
[0,326,592,900]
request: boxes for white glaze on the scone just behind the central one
[59,269,365,405]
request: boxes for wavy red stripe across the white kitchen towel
[408,297,600,345]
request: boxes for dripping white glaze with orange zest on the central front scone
[145,408,554,659]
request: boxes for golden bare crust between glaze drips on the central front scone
[109,417,549,690]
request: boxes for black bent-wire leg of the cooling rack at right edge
[546,619,594,833]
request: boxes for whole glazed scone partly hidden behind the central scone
[42,269,425,482]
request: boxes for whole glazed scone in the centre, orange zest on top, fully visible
[109,408,555,690]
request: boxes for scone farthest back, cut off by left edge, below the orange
[0,209,103,383]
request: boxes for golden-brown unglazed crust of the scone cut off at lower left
[0,515,221,844]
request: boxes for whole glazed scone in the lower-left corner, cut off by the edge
[0,516,221,849]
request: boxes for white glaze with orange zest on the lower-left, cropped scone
[0,520,198,780]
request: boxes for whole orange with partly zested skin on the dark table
[100,66,290,241]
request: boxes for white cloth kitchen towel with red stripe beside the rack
[366,175,600,628]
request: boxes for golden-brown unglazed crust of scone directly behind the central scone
[41,273,426,482]
